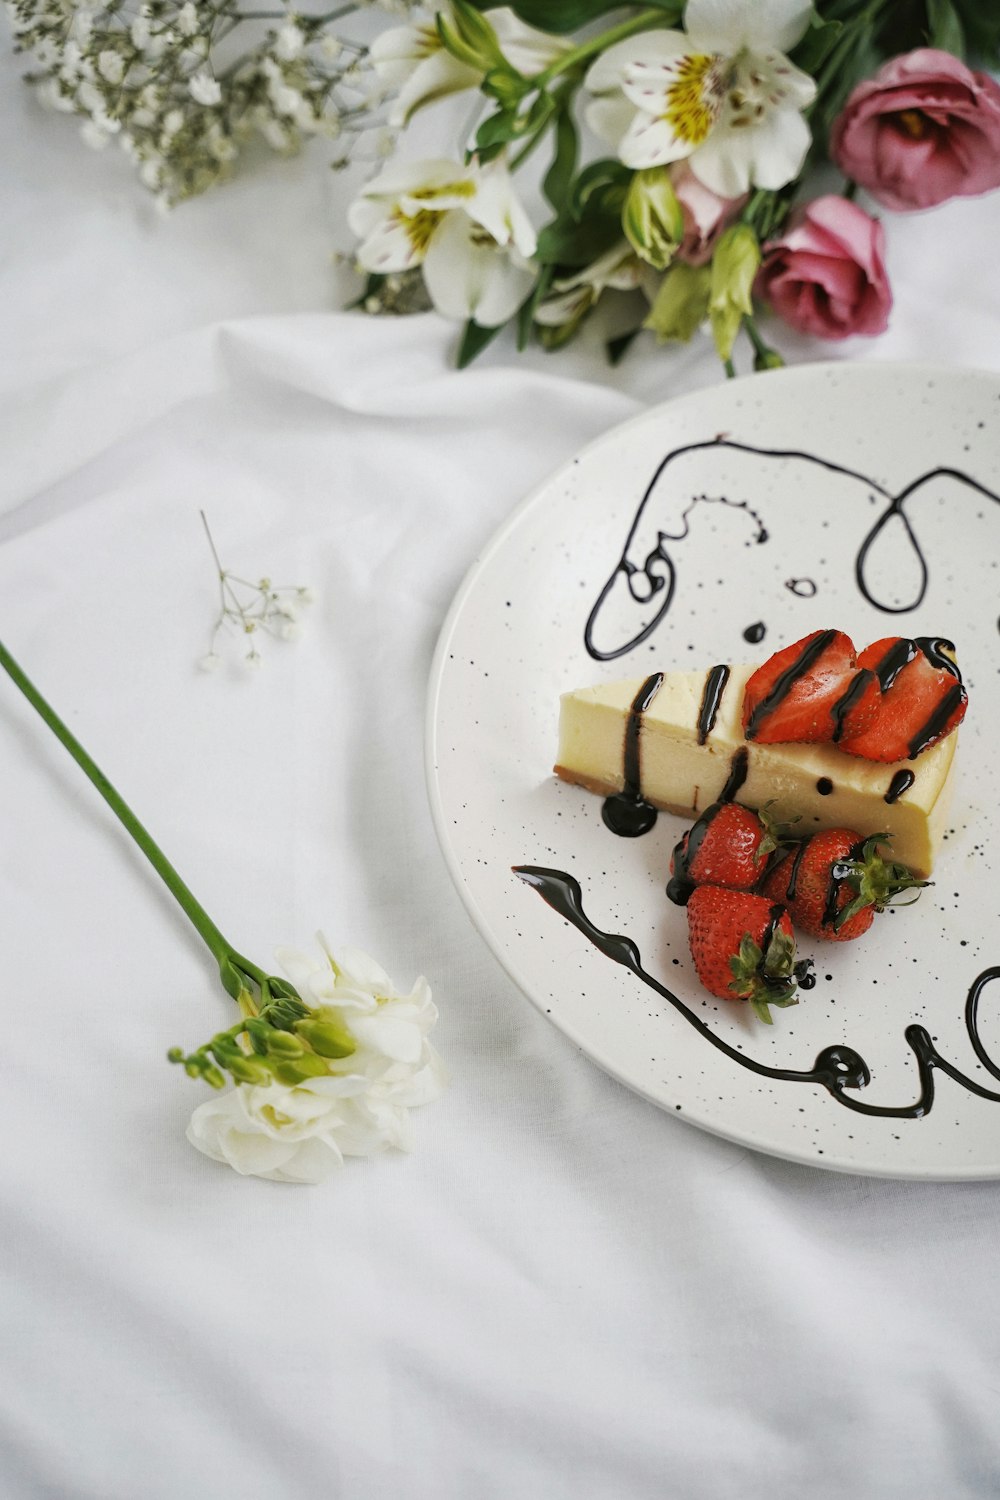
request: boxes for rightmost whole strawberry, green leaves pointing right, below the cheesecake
[763,828,928,942]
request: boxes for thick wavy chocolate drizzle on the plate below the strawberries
[514,864,1000,1119]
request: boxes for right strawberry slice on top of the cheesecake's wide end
[838,636,969,762]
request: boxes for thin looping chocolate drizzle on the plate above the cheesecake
[583,437,1000,665]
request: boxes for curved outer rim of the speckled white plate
[423,359,1000,1182]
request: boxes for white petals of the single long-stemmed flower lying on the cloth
[187,945,447,1182]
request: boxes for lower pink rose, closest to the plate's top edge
[754,194,892,339]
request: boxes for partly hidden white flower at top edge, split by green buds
[369,5,570,129]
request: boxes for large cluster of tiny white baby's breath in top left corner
[6,0,419,209]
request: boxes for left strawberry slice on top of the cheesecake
[744,630,877,744]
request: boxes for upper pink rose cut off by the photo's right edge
[831,47,1000,212]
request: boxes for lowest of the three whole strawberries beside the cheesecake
[688,885,802,1026]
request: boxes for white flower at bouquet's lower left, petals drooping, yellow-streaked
[348,158,535,329]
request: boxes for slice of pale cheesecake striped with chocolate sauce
[555,663,958,876]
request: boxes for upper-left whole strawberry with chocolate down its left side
[667,803,783,906]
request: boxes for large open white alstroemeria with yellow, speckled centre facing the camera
[586,0,816,198]
